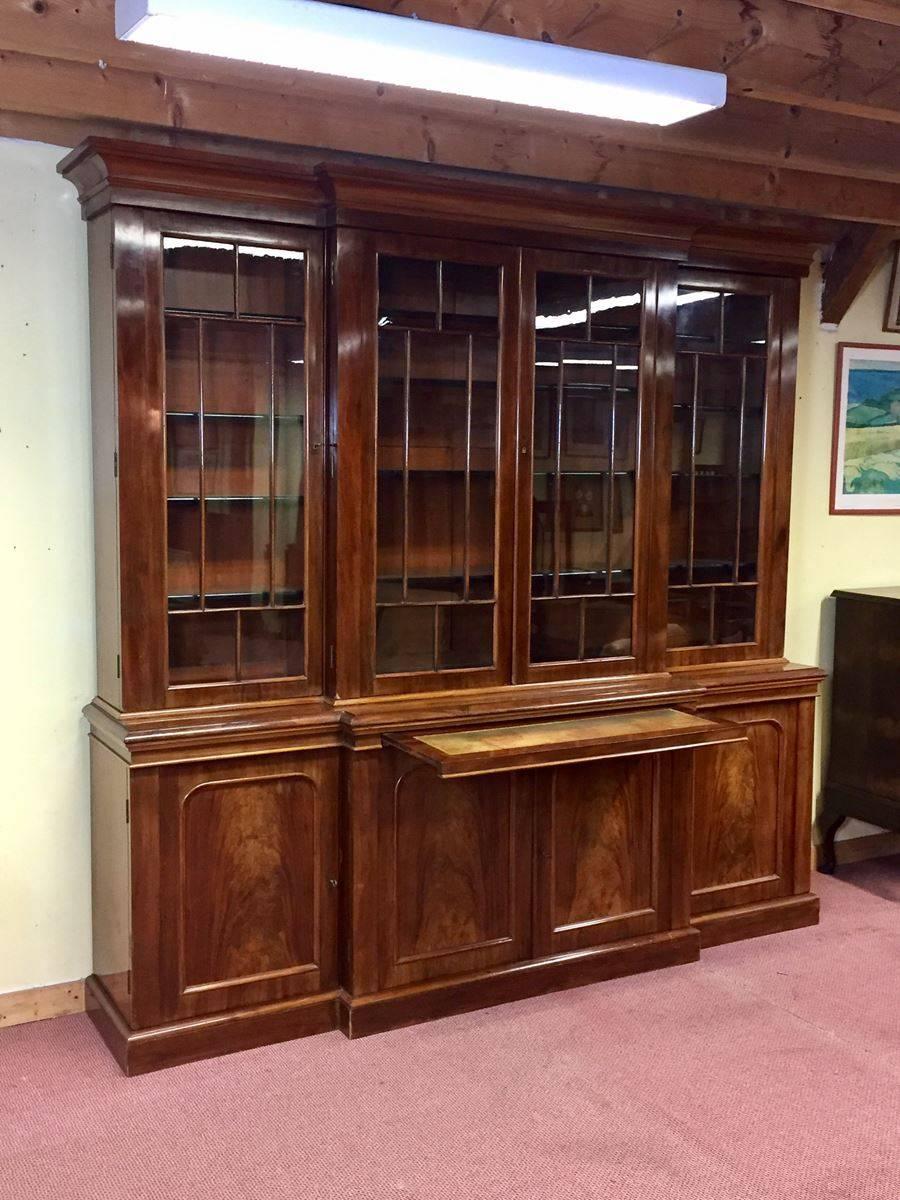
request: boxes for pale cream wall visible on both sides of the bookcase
[0,139,900,992]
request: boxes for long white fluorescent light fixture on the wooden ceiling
[115,0,726,125]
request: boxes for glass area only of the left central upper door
[376,256,499,673]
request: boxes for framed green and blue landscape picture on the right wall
[830,342,900,515]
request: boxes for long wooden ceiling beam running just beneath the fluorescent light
[0,46,900,223]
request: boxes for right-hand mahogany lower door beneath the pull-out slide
[535,756,667,954]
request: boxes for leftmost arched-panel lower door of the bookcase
[131,750,337,1025]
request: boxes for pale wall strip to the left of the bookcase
[0,139,95,992]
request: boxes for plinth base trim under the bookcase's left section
[85,976,337,1075]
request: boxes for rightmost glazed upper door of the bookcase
[666,270,794,666]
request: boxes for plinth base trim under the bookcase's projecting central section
[338,929,700,1038]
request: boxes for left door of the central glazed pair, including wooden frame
[332,230,518,697]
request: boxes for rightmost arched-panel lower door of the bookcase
[691,704,796,913]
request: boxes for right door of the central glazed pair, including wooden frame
[516,251,655,682]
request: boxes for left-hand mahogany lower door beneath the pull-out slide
[379,755,530,986]
